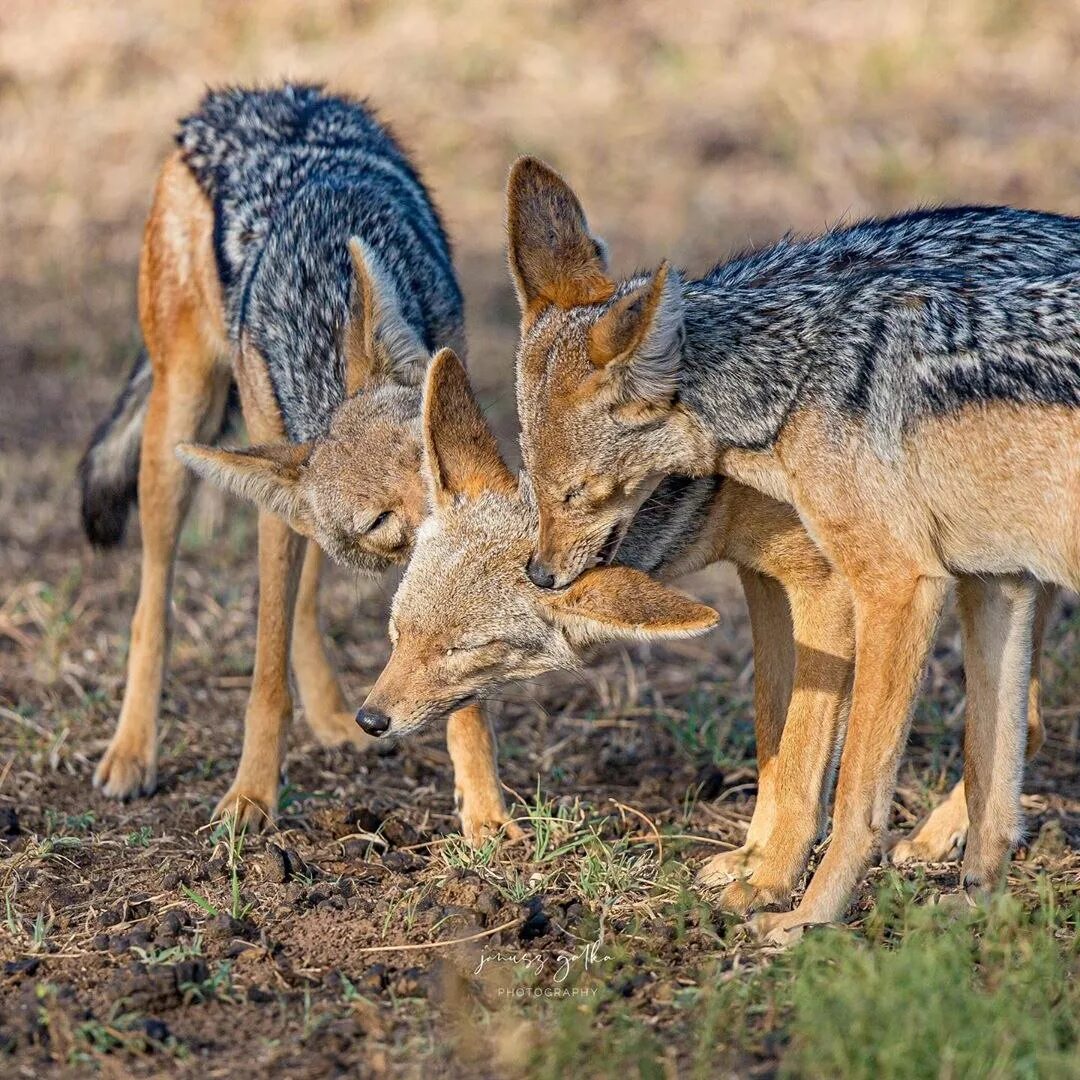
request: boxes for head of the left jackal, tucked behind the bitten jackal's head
[177,238,429,573]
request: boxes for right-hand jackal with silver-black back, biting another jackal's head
[509,159,1080,936]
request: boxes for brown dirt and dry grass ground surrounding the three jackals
[0,0,1080,1078]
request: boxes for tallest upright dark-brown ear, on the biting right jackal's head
[507,158,615,315]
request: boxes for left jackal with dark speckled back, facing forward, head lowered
[80,85,505,835]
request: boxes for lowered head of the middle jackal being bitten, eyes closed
[356,349,717,735]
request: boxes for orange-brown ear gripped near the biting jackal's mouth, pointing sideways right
[541,566,719,647]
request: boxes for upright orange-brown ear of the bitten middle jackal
[423,349,517,507]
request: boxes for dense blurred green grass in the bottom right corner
[783,881,1080,1080]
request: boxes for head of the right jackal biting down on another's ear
[507,158,700,589]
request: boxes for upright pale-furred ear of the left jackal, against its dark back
[342,237,428,396]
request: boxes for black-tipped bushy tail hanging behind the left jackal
[79,349,152,548]
